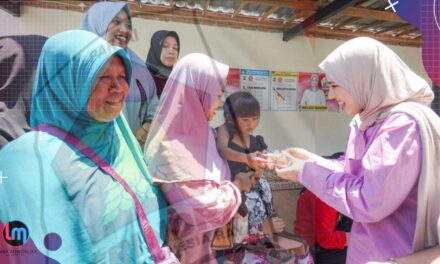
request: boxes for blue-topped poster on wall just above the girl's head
[240,70,270,111]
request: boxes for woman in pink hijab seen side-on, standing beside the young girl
[144,53,251,263]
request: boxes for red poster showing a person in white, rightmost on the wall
[297,72,327,111]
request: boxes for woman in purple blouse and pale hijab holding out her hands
[277,37,440,263]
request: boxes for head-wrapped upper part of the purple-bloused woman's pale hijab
[319,37,434,130]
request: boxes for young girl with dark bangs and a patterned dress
[217,91,312,263]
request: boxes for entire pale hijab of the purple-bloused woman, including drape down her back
[319,37,440,252]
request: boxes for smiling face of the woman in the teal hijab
[87,56,128,122]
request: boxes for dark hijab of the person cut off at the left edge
[0,35,47,149]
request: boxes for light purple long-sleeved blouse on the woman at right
[299,113,422,263]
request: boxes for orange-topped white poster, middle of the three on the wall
[270,71,298,111]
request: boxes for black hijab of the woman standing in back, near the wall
[146,30,180,78]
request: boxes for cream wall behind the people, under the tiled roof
[0,7,428,155]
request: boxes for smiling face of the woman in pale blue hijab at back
[105,10,131,48]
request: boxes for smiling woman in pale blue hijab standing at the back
[81,2,159,146]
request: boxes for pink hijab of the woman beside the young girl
[144,53,230,183]
